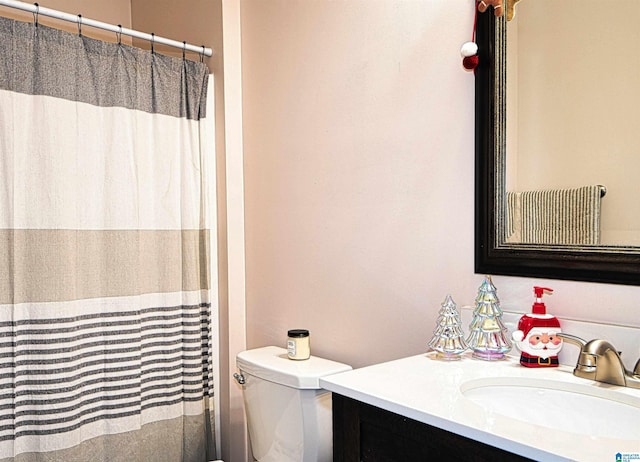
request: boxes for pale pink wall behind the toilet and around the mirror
[242,0,640,376]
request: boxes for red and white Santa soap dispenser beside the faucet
[512,287,562,367]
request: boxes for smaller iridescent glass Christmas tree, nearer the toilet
[429,295,467,361]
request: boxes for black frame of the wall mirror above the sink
[475,13,640,285]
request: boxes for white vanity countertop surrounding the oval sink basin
[320,353,640,462]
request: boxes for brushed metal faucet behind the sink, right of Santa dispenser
[558,333,640,388]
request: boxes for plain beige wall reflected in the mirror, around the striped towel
[507,0,640,246]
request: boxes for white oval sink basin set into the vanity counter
[460,377,640,441]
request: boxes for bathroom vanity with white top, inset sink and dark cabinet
[320,353,640,462]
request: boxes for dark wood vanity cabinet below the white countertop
[332,393,531,462]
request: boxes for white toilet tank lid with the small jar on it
[236,346,351,389]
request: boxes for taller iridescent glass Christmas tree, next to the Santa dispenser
[467,276,512,361]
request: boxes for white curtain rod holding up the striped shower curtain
[0,0,213,56]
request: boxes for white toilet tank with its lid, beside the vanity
[234,346,351,462]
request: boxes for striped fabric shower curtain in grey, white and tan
[0,14,217,462]
